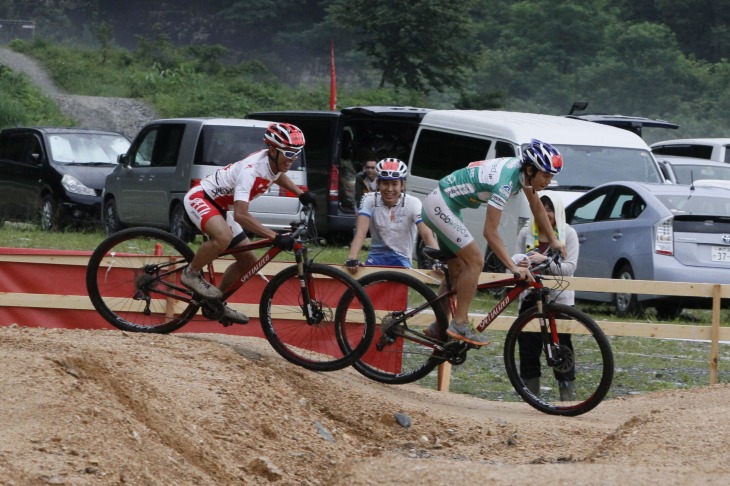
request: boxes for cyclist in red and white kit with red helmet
[180,123,314,324]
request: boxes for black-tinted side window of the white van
[411,129,492,180]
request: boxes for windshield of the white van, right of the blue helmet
[551,145,664,190]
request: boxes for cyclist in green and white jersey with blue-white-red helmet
[421,139,565,346]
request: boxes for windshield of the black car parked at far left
[48,133,130,164]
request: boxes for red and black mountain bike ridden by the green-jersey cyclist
[340,248,614,416]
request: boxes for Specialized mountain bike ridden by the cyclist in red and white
[86,207,376,371]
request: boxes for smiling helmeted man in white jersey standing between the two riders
[345,159,437,274]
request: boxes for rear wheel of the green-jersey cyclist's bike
[340,271,448,385]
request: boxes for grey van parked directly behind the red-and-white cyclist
[103,118,307,241]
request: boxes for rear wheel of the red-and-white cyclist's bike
[86,228,198,334]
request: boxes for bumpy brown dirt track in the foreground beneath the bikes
[0,326,730,485]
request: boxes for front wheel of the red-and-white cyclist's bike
[259,263,375,371]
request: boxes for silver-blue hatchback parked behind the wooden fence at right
[566,182,730,319]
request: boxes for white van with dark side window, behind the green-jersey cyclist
[406,110,664,270]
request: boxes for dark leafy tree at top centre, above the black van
[328,0,478,92]
